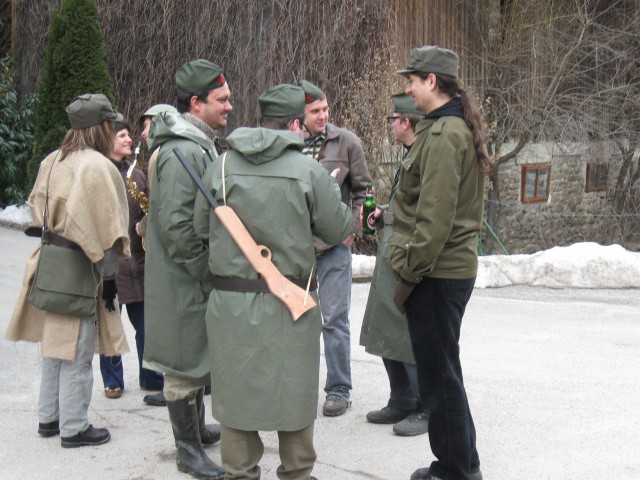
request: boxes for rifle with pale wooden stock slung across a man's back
[173,147,316,321]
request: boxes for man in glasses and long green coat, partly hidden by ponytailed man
[360,93,429,436]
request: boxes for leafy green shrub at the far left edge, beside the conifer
[0,56,35,205]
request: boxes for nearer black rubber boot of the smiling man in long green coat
[167,397,224,480]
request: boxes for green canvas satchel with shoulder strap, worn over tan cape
[28,155,100,317]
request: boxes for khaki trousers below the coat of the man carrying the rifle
[220,423,316,480]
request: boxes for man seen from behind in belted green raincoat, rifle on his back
[194,84,353,480]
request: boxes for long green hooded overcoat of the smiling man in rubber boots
[144,114,217,383]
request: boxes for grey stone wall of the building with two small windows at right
[484,142,628,254]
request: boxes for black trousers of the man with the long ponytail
[405,278,480,480]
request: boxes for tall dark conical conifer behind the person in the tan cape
[28,0,113,185]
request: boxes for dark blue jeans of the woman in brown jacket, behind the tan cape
[100,302,164,390]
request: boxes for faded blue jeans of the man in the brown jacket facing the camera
[317,243,351,399]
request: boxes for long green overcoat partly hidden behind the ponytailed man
[360,199,416,363]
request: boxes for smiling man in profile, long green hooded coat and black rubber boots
[144,60,232,479]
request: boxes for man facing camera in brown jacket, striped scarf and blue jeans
[299,80,371,417]
